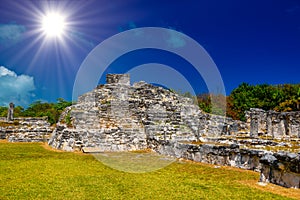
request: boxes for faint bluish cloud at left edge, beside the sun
[0,24,26,46]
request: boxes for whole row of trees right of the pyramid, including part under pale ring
[197,83,300,120]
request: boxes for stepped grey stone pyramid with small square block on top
[49,74,246,151]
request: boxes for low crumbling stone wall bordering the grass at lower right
[150,141,300,188]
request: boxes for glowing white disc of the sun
[42,13,66,37]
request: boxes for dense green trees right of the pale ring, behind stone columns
[227,83,300,120]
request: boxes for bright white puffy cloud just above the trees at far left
[0,66,35,106]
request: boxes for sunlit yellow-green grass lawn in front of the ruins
[0,142,299,200]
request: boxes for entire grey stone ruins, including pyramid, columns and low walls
[0,74,300,188]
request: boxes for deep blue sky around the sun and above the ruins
[0,0,300,106]
